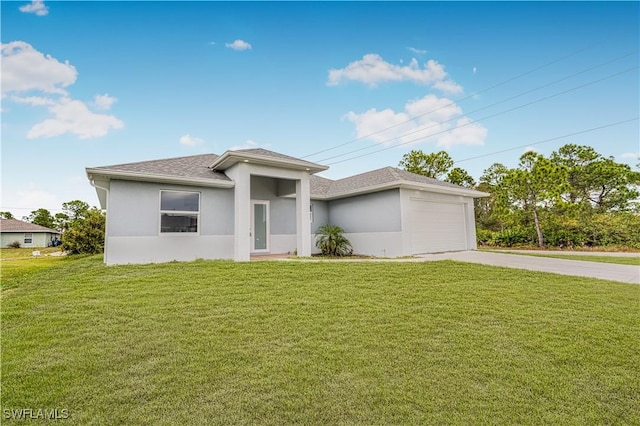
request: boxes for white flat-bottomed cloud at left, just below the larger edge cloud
[27,97,124,139]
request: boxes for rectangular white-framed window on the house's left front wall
[160,191,200,234]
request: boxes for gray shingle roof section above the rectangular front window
[93,154,231,181]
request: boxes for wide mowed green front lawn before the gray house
[2,257,640,425]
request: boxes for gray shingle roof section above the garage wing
[311,167,476,198]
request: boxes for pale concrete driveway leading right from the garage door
[417,251,640,284]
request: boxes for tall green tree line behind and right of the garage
[399,144,640,249]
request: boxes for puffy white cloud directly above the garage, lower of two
[345,94,488,148]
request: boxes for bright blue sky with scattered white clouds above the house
[0,1,640,217]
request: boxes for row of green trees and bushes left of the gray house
[0,200,106,254]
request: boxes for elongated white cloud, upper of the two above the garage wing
[327,53,462,93]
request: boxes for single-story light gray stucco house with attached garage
[87,149,488,264]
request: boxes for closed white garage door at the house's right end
[410,199,467,254]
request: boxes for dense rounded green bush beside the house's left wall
[62,207,105,254]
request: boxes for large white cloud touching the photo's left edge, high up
[1,41,78,97]
